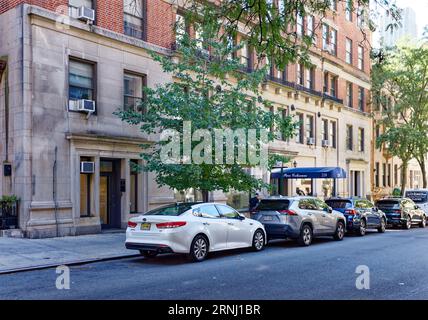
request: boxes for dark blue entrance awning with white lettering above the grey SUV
[270,167,346,179]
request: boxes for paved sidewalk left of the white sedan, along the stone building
[0,233,138,274]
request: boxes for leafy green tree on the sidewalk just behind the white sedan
[116,17,295,201]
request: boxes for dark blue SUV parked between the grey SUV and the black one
[325,198,387,236]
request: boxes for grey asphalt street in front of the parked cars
[0,227,428,300]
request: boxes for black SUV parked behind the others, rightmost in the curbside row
[376,198,426,229]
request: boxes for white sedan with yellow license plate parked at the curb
[125,203,266,261]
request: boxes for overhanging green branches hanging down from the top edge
[176,0,401,68]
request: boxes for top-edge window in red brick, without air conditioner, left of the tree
[123,0,144,39]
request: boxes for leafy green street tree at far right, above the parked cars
[372,44,428,190]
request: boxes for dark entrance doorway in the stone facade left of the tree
[99,159,121,229]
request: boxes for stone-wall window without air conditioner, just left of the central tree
[123,72,146,112]
